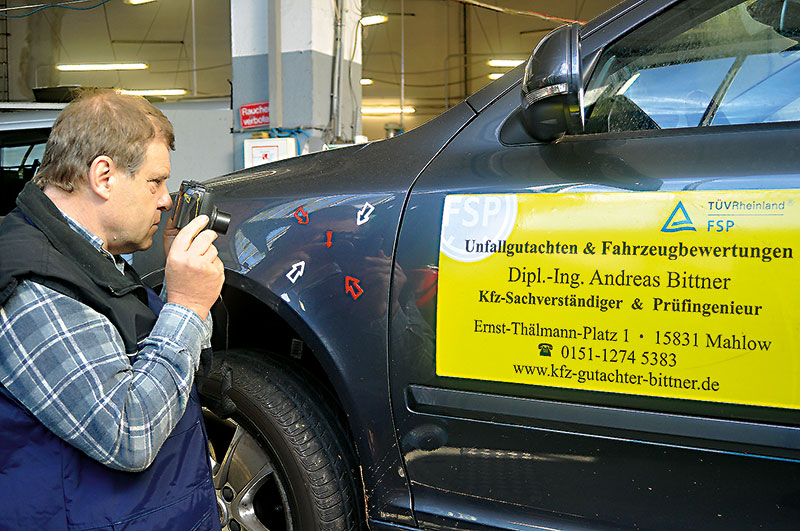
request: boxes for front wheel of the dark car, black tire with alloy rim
[197,350,362,531]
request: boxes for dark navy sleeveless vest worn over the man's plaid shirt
[0,183,220,531]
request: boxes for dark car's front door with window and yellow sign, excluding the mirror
[389,0,800,529]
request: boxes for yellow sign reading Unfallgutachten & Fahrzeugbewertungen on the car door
[436,190,800,409]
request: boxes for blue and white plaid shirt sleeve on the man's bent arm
[0,281,211,471]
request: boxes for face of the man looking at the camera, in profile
[105,140,172,254]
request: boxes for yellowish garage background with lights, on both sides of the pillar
[0,0,616,138]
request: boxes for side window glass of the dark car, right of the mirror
[586,0,800,133]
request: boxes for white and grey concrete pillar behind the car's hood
[231,0,361,169]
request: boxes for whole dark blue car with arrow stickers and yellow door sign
[135,0,800,530]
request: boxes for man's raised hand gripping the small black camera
[165,215,225,320]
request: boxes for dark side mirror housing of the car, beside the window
[522,23,585,142]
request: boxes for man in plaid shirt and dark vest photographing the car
[0,91,224,530]
